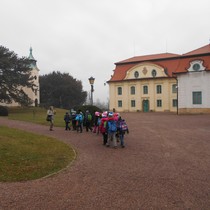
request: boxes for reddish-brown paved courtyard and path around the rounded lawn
[0,113,210,210]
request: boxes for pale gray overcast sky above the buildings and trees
[0,0,210,101]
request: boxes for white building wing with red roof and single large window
[175,45,210,113]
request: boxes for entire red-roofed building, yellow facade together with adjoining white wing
[108,45,210,113]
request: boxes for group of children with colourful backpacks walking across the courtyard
[64,110,129,148]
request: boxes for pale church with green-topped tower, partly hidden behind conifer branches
[0,48,40,106]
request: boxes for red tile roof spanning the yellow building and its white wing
[109,45,210,82]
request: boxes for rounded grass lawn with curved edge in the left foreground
[0,126,75,182]
